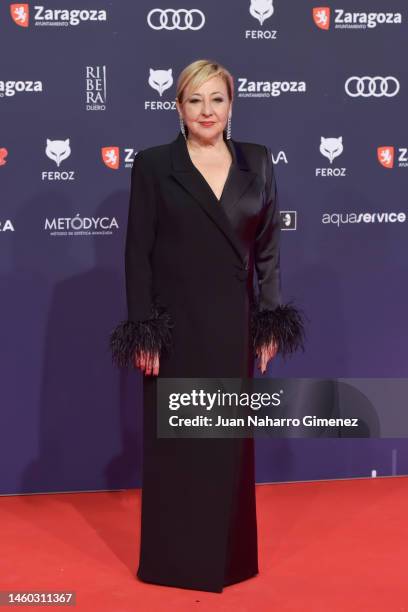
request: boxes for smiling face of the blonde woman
[176,76,231,140]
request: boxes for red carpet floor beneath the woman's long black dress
[0,477,408,612]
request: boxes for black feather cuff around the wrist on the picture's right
[251,302,305,356]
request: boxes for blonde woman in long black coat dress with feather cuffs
[110,60,303,592]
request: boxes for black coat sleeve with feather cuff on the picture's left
[109,151,173,367]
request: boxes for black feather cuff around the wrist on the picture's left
[109,304,174,367]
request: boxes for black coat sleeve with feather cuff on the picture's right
[251,147,304,355]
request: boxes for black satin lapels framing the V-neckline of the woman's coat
[170,131,256,264]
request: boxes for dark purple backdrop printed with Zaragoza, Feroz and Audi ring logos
[0,0,408,493]
